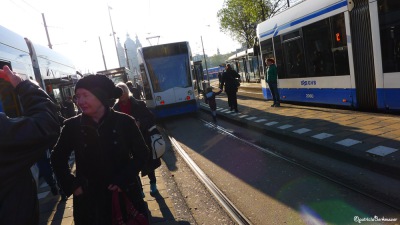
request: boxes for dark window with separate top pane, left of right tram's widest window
[282,31,306,78]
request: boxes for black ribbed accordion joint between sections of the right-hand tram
[350,0,377,111]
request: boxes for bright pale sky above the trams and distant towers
[0,0,240,73]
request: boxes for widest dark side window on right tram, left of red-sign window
[303,19,334,77]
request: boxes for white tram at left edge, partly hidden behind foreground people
[0,26,78,184]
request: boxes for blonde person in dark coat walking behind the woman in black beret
[114,83,161,195]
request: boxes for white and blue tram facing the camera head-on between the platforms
[138,42,199,118]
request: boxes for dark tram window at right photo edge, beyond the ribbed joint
[378,0,400,73]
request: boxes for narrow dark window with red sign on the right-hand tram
[331,13,350,75]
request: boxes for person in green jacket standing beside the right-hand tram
[265,58,281,107]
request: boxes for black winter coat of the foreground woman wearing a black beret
[51,109,149,225]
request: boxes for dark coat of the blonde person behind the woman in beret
[114,96,161,176]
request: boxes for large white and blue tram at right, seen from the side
[257,0,400,111]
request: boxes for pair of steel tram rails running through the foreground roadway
[162,118,400,224]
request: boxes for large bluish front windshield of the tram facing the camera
[146,54,191,92]
